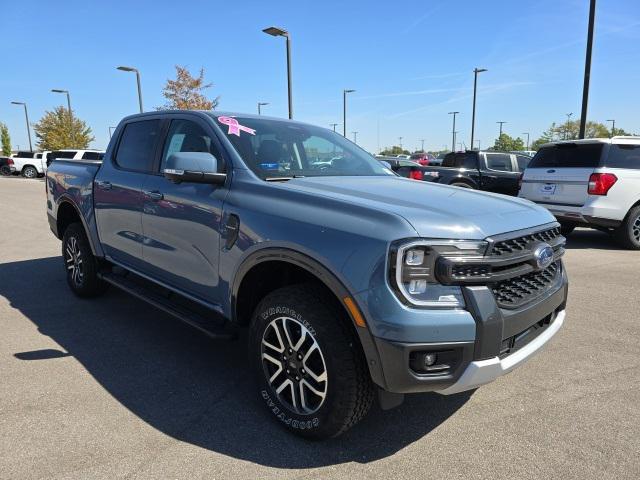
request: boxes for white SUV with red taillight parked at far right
[519,137,640,249]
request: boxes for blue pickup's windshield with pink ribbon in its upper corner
[211,114,393,180]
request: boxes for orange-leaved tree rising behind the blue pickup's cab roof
[158,65,220,110]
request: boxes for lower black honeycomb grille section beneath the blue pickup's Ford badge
[491,261,562,308]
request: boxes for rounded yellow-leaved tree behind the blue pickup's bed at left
[33,106,95,150]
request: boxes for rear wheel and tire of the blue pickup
[62,223,108,298]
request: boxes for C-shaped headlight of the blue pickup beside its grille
[389,240,487,308]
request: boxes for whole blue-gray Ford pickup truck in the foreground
[46,111,567,438]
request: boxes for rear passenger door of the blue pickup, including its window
[93,118,163,270]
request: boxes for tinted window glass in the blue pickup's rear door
[116,120,160,172]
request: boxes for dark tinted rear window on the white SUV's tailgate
[529,143,603,168]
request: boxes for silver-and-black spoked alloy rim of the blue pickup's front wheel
[261,317,328,415]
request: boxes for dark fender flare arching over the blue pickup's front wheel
[231,247,385,385]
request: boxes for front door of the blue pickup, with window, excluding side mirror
[142,114,228,303]
